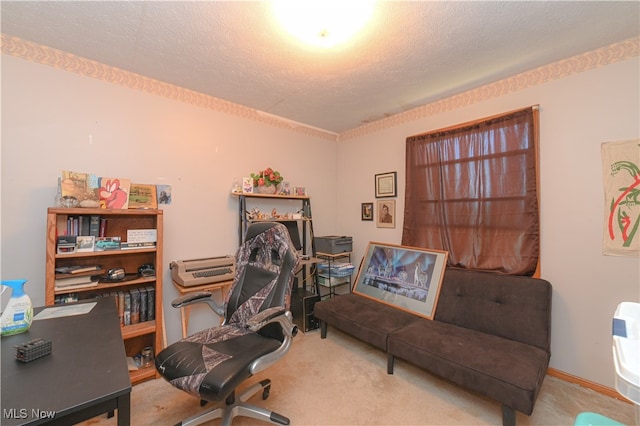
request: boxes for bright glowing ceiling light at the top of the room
[272,0,375,48]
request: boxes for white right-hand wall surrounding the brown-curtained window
[338,58,640,387]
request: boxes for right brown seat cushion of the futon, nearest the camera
[388,320,549,414]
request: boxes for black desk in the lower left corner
[0,298,131,426]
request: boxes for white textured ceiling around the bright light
[0,0,640,133]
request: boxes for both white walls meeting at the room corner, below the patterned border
[0,50,640,386]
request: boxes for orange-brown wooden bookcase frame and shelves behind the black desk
[45,208,165,384]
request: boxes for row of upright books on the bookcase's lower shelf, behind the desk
[55,286,156,327]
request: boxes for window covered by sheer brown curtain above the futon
[402,107,540,275]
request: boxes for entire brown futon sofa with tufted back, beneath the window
[314,268,552,425]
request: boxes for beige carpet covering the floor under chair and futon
[84,328,636,426]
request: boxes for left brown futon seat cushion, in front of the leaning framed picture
[313,294,420,351]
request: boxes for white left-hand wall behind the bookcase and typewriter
[0,55,336,342]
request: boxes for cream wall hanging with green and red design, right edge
[602,139,640,256]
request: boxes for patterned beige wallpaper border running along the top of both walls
[1,34,640,140]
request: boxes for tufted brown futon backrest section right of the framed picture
[435,268,552,351]
